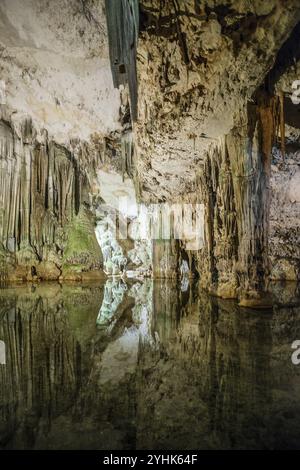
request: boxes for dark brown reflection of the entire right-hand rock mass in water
[137,280,300,449]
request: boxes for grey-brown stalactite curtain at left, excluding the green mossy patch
[0,119,102,280]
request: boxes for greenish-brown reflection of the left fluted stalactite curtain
[0,285,102,448]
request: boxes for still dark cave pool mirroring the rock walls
[0,279,300,449]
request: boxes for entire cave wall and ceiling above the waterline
[0,0,300,307]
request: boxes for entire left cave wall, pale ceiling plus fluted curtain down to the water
[0,0,132,281]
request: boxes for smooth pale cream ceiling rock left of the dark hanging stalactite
[0,0,120,144]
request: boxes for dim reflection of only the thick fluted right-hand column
[199,296,271,447]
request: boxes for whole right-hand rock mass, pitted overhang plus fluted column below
[134,0,300,307]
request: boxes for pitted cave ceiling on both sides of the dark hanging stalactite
[0,0,300,202]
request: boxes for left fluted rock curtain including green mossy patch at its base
[0,114,102,281]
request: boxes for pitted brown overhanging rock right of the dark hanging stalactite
[135,0,300,200]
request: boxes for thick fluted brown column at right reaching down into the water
[198,90,278,305]
